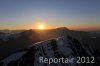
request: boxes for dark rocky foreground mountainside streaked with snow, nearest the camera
[0,36,100,66]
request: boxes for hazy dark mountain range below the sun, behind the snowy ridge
[0,27,100,57]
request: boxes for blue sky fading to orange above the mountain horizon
[0,0,100,30]
